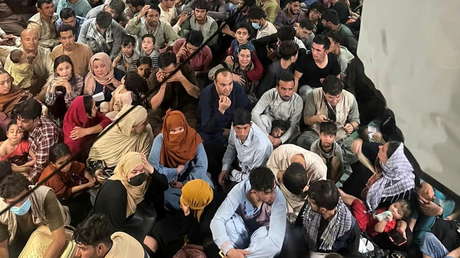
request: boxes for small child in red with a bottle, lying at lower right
[340,188,411,237]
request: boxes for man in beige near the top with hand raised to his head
[126,5,179,49]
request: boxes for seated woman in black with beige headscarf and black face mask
[94,152,167,245]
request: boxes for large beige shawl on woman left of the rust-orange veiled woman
[89,105,153,167]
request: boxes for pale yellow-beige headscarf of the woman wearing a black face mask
[109,152,148,217]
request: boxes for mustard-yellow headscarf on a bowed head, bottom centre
[180,179,214,221]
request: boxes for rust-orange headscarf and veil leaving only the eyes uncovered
[160,110,201,168]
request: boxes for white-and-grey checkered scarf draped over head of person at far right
[366,143,415,211]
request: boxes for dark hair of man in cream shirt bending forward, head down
[283,162,308,195]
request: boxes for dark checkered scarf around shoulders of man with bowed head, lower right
[303,198,353,251]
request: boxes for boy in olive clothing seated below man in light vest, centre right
[310,122,344,183]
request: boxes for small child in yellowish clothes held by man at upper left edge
[7,49,33,89]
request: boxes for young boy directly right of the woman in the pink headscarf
[113,35,139,73]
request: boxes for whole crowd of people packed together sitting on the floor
[0,0,460,258]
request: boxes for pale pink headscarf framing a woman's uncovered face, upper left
[83,52,121,95]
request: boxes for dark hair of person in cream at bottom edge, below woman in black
[73,214,115,246]
